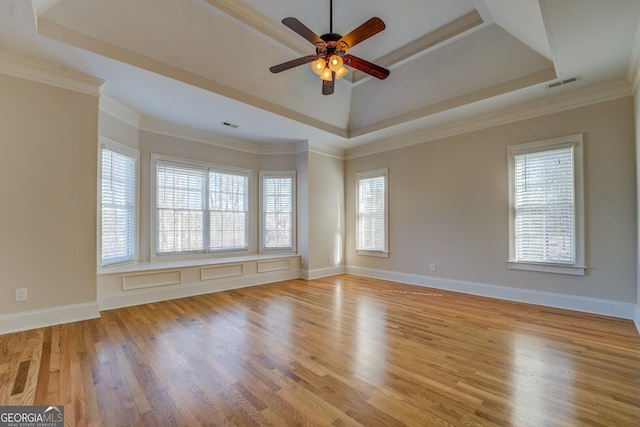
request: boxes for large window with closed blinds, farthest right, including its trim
[509,135,584,275]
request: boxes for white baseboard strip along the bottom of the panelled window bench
[98,270,300,311]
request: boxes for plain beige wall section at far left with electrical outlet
[0,74,98,314]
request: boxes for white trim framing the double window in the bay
[149,153,254,262]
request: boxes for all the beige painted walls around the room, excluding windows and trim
[0,66,640,328]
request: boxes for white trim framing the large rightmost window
[507,134,587,276]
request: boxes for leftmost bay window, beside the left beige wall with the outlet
[99,137,138,266]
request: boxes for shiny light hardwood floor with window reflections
[0,275,640,426]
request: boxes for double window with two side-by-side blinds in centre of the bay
[152,155,249,255]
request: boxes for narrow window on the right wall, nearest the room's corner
[356,169,389,256]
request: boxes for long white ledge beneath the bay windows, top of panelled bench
[98,253,298,275]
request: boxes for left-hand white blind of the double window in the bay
[156,162,207,254]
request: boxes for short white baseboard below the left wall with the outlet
[0,302,100,334]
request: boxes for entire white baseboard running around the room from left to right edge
[5,266,640,334]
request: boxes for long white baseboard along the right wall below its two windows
[346,266,640,322]
